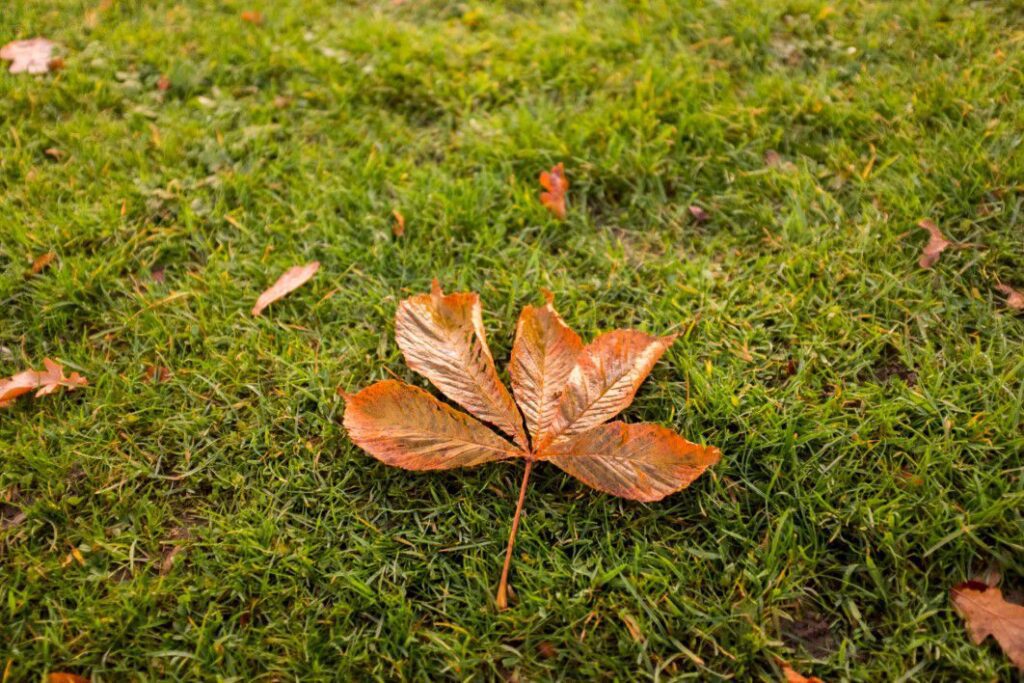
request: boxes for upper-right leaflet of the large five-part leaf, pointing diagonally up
[536,330,676,453]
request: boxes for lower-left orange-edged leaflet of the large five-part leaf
[344,380,526,470]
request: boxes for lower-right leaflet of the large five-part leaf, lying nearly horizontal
[543,422,720,503]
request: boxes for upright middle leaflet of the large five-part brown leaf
[509,293,583,443]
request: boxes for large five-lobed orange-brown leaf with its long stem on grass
[338,280,720,609]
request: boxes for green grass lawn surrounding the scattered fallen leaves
[0,0,1024,682]
